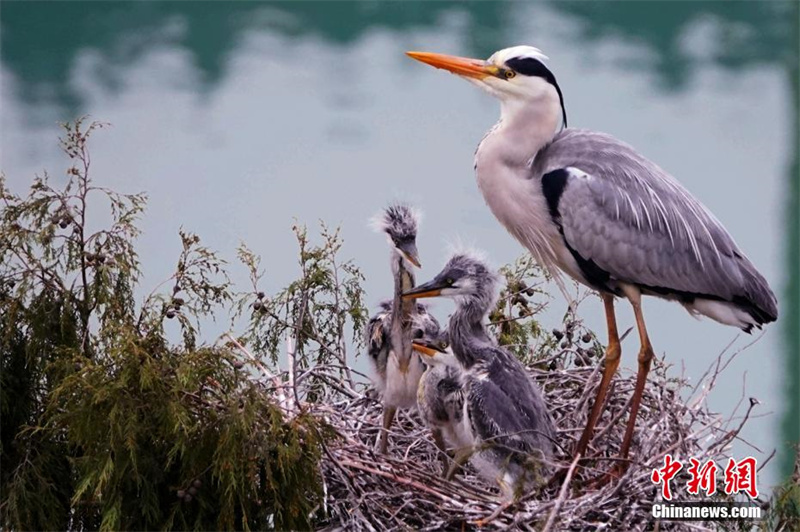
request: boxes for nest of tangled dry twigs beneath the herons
[314,338,768,530]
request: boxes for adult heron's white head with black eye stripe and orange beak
[407,46,567,127]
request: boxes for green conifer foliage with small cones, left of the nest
[0,121,338,530]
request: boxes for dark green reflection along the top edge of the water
[0,1,796,116]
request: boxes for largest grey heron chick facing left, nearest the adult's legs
[403,253,555,500]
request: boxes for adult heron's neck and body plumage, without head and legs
[475,63,777,331]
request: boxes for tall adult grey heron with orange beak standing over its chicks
[408,46,778,478]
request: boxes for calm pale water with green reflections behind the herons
[0,2,800,485]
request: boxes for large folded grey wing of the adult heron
[534,130,777,323]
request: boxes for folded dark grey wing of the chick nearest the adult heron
[467,348,555,456]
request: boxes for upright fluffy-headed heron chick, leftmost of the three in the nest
[367,204,439,453]
